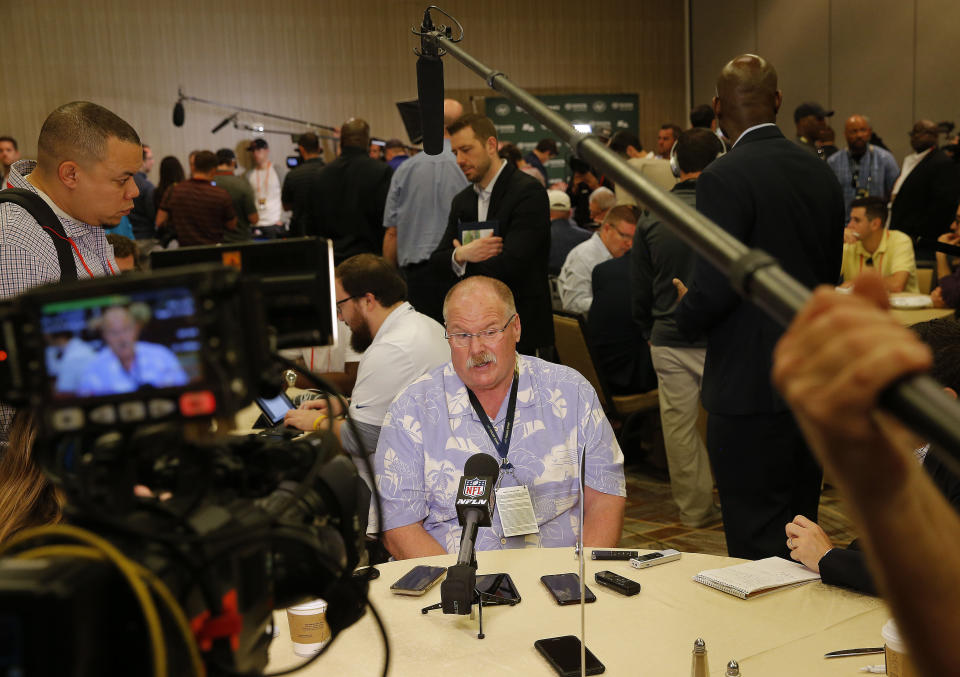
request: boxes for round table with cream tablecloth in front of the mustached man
[268,548,890,677]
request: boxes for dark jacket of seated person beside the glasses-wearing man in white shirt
[587,252,657,395]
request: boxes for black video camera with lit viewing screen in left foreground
[0,265,370,675]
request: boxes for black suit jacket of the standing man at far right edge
[890,148,960,251]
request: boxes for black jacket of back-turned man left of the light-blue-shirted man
[297,146,393,263]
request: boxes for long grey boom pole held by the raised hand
[413,10,960,474]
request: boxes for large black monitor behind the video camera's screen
[150,237,337,348]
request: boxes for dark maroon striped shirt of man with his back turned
[160,179,236,247]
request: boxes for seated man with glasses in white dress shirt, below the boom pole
[557,205,639,315]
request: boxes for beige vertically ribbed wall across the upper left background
[0,0,687,177]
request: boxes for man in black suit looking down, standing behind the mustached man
[430,113,553,359]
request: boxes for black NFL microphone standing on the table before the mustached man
[440,454,500,615]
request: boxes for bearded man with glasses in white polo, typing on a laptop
[285,254,449,475]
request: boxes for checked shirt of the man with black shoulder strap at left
[0,160,118,448]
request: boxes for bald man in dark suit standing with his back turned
[676,54,844,559]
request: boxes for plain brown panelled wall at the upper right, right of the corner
[689,0,960,161]
